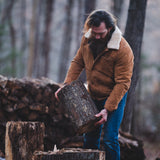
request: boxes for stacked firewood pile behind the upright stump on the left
[0,76,73,153]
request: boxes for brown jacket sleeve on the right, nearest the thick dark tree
[104,45,134,111]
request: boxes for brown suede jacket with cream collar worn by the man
[64,27,134,111]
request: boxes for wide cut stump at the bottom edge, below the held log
[32,148,105,160]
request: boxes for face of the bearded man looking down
[91,22,110,40]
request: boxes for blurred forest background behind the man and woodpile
[0,0,160,159]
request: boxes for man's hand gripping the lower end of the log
[95,109,108,125]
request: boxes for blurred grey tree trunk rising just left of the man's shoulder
[58,0,74,82]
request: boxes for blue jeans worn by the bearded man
[84,93,127,160]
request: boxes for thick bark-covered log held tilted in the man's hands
[58,80,100,134]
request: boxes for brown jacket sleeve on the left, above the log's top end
[64,36,84,84]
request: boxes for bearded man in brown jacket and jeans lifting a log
[55,10,134,160]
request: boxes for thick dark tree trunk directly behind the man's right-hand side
[122,0,147,132]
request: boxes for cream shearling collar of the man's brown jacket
[84,26,122,49]
